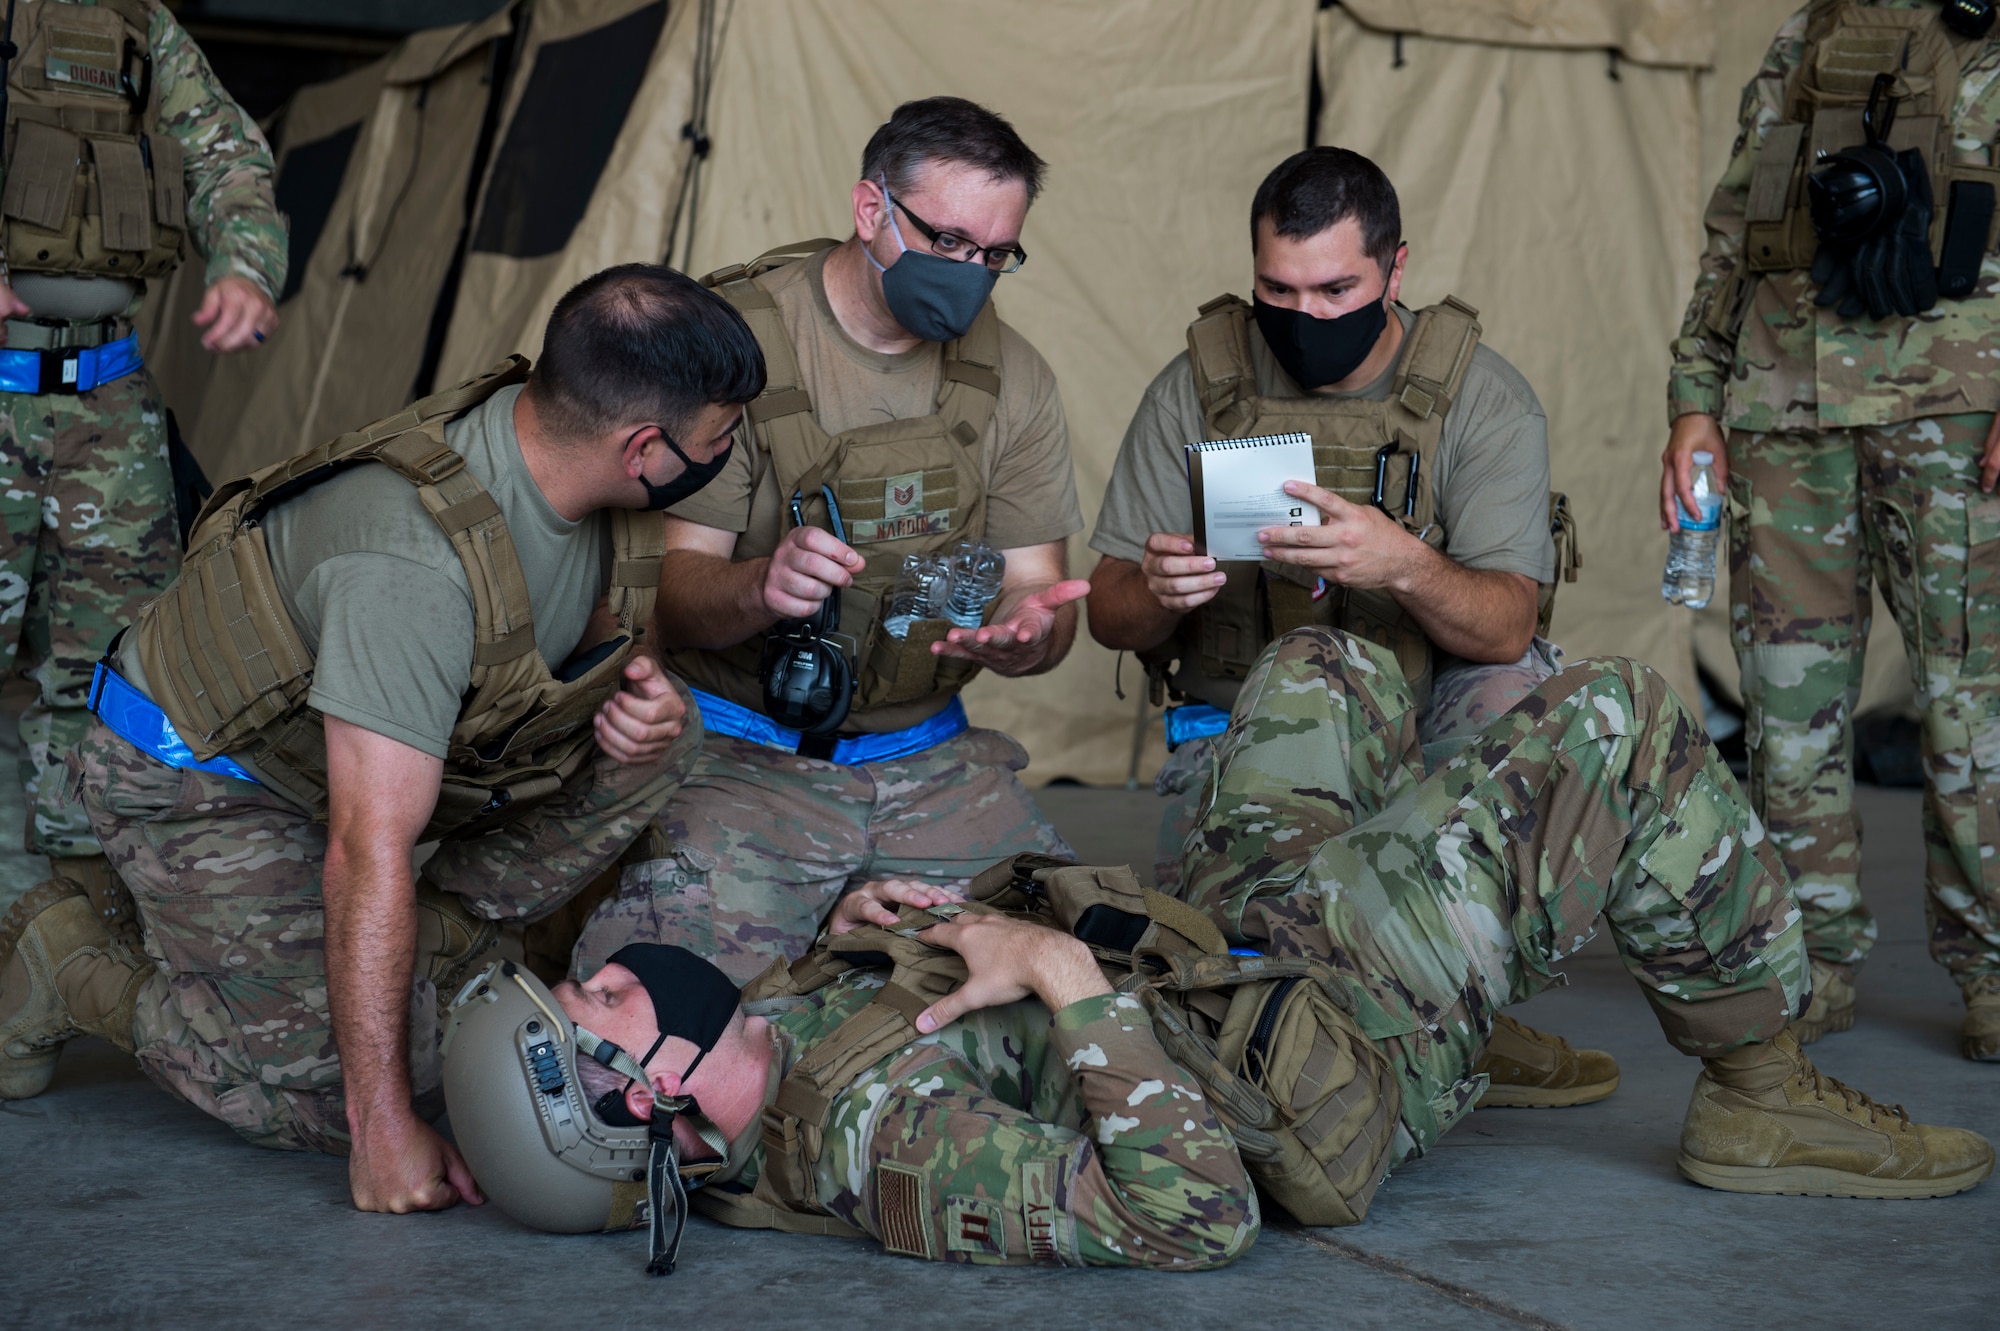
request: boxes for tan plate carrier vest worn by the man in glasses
[668,240,1000,713]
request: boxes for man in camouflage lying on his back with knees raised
[446,628,1994,1269]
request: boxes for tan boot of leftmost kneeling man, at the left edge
[0,879,152,1099]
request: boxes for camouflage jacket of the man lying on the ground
[742,971,1258,1271]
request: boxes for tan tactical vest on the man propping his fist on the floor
[134,356,664,841]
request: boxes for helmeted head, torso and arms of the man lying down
[444,881,1258,1273]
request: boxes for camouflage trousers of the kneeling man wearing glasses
[570,729,1072,981]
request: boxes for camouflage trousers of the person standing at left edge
[0,370,180,855]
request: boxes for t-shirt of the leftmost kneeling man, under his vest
[120,386,612,779]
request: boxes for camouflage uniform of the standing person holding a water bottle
[1668,0,2000,981]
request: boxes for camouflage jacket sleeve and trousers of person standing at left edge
[0,8,286,855]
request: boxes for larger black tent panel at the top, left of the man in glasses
[472,0,666,258]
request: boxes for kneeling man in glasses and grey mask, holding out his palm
[576,98,1088,979]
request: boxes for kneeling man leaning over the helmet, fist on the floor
[0,264,764,1211]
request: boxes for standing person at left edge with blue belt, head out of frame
[0,0,286,923]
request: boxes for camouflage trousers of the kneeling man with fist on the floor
[72,721,700,1153]
